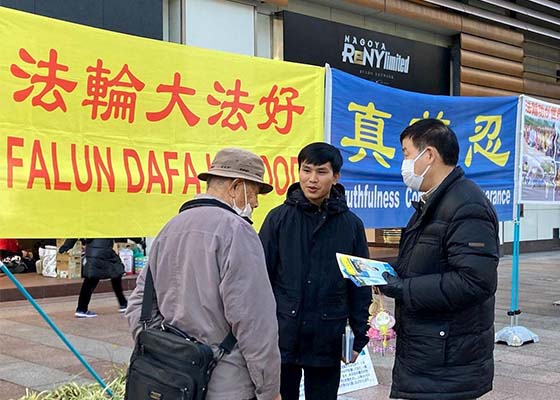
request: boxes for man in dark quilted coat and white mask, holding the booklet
[379,119,499,400]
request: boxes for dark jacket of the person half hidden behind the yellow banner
[58,239,124,279]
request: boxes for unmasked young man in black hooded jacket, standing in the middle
[259,143,371,400]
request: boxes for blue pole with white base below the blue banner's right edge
[495,204,539,347]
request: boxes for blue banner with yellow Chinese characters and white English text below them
[326,69,518,228]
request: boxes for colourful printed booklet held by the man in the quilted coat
[336,253,397,286]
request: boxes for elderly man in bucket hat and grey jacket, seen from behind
[129,148,280,400]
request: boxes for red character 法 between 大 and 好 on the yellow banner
[206,79,255,131]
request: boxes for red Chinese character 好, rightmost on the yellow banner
[257,85,305,135]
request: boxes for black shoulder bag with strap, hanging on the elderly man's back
[125,266,237,400]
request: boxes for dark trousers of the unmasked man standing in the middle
[280,364,340,400]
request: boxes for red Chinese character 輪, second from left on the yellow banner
[82,59,145,123]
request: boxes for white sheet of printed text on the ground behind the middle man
[299,347,379,400]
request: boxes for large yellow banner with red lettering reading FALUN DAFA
[0,7,324,238]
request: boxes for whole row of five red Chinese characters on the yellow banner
[10,48,305,135]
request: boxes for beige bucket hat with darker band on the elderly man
[198,147,273,194]
